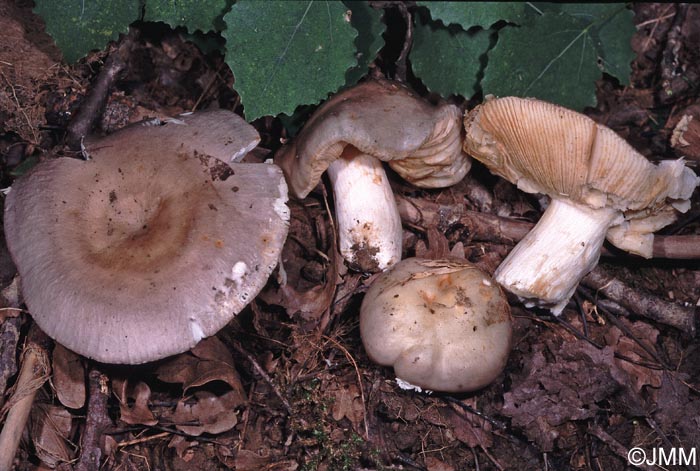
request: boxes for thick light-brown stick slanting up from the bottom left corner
[0,324,51,471]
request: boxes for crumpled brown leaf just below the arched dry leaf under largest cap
[169,391,240,437]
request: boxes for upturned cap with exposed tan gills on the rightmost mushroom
[464,97,698,257]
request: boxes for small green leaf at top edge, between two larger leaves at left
[143,0,226,33]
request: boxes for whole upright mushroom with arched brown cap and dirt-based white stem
[275,80,471,271]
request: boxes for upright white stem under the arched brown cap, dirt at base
[328,153,402,271]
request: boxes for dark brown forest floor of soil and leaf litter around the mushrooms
[0,1,700,471]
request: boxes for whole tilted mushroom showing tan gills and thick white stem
[464,97,700,314]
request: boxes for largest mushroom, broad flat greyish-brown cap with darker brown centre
[5,110,289,364]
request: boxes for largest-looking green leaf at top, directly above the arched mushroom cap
[223,0,357,121]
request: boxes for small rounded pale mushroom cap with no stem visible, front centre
[360,258,512,392]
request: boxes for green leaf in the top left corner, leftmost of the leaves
[34,0,141,62]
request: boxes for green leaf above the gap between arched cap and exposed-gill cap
[410,16,490,98]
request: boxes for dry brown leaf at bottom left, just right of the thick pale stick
[29,403,74,468]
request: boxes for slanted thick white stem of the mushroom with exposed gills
[494,199,621,315]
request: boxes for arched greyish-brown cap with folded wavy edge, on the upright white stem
[275,80,471,198]
